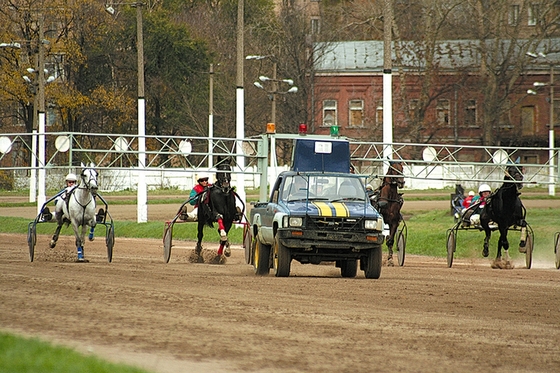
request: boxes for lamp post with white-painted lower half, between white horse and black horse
[105,1,148,223]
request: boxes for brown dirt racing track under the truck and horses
[0,202,560,373]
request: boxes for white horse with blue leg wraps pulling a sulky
[50,163,98,262]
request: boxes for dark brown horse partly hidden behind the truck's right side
[371,161,404,266]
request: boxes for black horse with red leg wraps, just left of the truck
[195,158,243,258]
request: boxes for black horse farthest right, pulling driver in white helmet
[480,163,527,268]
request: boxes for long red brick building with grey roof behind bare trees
[310,39,560,161]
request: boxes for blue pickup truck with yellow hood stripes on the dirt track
[246,139,384,278]
